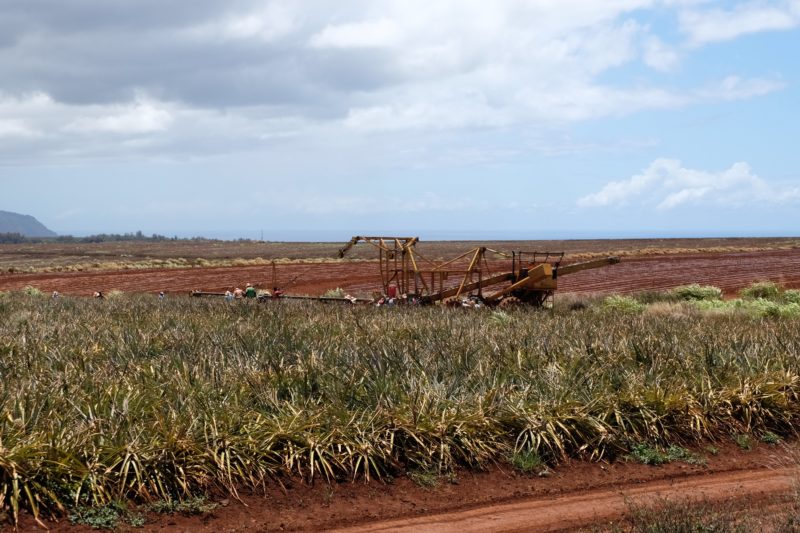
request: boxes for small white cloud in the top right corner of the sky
[680,2,800,46]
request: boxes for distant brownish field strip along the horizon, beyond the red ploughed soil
[0,236,800,272]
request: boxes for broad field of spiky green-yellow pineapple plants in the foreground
[0,291,800,520]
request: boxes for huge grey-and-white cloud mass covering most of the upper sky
[0,0,797,164]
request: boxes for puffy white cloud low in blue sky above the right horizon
[578,159,800,210]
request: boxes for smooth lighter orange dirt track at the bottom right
[333,467,800,533]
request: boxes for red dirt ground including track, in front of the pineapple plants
[20,443,800,533]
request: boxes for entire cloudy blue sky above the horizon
[0,0,800,241]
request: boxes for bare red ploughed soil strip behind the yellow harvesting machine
[0,248,800,296]
